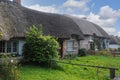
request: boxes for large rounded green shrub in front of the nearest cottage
[23,25,59,67]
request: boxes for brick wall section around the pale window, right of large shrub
[63,39,79,55]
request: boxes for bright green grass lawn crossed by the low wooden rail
[20,56,120,80]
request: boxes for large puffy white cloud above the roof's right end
[87,6,120,34]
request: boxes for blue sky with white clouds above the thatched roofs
[22,0,120,36]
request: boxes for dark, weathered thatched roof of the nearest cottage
[0,0,83,40]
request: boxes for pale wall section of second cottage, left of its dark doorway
[80,36,90,50]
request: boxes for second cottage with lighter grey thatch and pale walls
[66,15,109,50]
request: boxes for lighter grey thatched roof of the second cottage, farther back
[66,15,109,38]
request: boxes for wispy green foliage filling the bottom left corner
[0,53,19,80]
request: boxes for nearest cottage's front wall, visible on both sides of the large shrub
[1,39,79,55]
